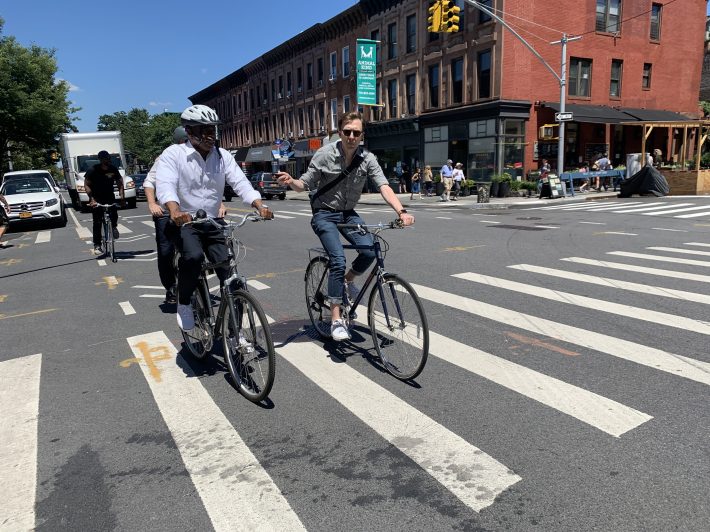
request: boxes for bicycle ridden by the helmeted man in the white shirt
[182,212,275,403]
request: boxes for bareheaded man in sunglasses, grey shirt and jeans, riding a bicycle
[277,112,414,342]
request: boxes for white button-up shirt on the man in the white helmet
[155,142,261,218]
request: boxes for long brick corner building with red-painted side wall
[190,0,706,180]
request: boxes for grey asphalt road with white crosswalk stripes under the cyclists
[0,198,710,531]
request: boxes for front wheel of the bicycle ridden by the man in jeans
[367,274,429,381]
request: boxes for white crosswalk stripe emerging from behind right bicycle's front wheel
[356,316,653,437]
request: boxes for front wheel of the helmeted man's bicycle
[222,290,276,403]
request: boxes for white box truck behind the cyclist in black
[59,131,136,210]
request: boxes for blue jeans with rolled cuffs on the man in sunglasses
[311,210,375,305]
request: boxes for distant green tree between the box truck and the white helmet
[98,108,180,165]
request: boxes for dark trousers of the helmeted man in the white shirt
[176,225,229,305]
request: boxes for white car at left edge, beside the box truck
[0,174,67,227]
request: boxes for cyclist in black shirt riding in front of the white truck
[84,150,126,255]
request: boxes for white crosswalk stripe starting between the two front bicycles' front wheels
[278,342,521,512]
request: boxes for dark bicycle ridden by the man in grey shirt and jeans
[304,221,429,381]
